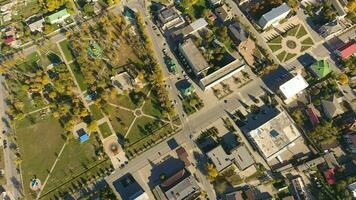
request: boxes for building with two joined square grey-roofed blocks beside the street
[207,145,255,172]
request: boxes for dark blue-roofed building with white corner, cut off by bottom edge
[113,174,149,200]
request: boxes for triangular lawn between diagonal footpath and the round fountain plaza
[43,135,100,193]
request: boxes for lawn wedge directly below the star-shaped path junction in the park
[127,116,156,144]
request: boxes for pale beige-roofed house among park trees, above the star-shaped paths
[110,72,135,93]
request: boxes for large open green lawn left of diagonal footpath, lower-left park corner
[16,116,65,199]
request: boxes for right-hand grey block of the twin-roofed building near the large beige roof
[231,145,255,170]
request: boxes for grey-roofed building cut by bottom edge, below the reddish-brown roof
[153,168,200,200]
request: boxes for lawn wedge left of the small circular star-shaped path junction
[104,105,135,136]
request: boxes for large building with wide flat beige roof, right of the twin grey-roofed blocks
[247,111,303,162]
